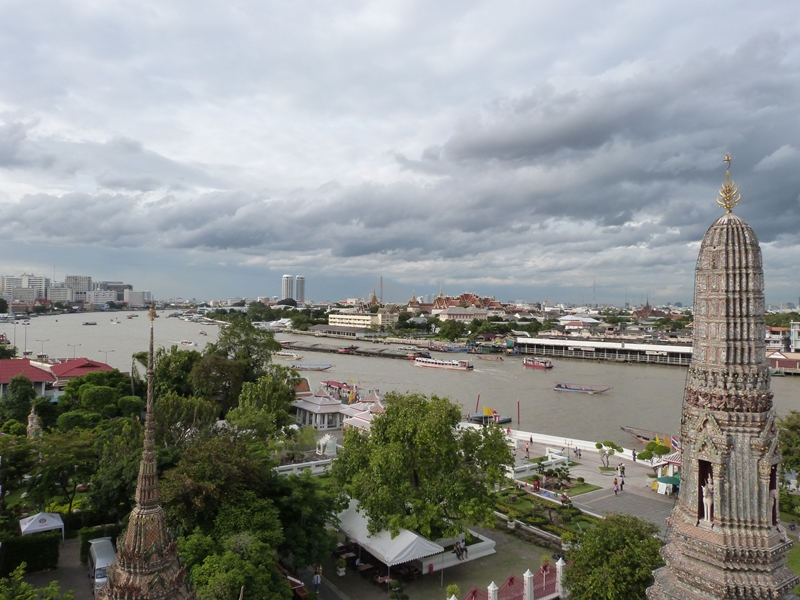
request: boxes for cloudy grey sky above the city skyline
[0,0,800,303]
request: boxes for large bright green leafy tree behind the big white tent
[332,393,513,539]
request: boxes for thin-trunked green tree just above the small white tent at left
[34,430,97,513]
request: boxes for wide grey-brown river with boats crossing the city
[0,311,800,447]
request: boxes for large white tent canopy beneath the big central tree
[339,500,444,567]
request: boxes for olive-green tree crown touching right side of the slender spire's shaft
[153,391,218,448]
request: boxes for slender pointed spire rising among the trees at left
[102,304,194,600]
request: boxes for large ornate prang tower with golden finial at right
[647,156,800,600]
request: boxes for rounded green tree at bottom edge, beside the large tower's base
[564,514,664,600]
